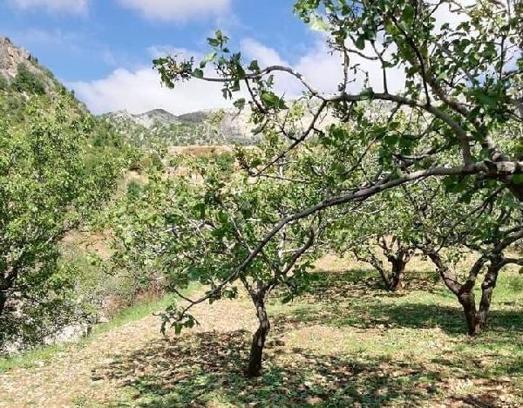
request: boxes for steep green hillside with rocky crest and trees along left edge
[0,37,137,354]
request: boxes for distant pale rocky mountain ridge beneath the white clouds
[101,109,259,146]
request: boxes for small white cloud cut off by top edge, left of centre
[118,0,231,21]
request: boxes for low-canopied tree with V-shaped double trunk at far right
[417,188,523,336]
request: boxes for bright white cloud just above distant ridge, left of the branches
[69,68,235,114]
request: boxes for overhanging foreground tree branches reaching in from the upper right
[154,0,523,318]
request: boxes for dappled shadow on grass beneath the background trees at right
[290,270,523,341]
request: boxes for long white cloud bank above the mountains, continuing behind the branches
[69,35,410,114]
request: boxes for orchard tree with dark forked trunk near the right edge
[372,179,523,336]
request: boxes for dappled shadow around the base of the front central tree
[96,331,446,408]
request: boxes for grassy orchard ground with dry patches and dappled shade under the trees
[0,259,523,408]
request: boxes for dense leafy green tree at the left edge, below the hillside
[0,93,122,343]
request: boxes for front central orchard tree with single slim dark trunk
[113,143,334,377]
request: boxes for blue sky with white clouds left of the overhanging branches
[0,0,344,113]
